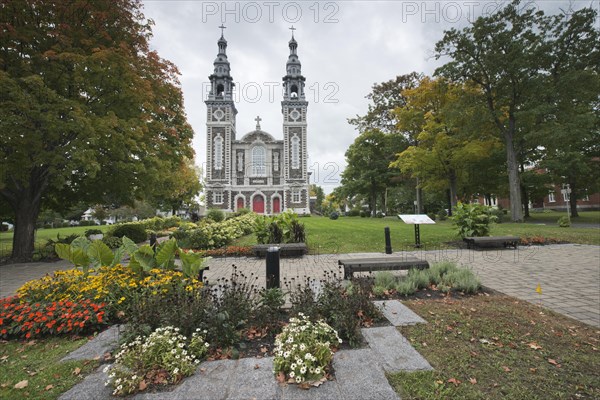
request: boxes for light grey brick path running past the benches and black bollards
[0,244,600,327]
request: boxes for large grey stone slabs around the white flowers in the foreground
[60,300,432,400]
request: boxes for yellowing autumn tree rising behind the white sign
[391,77,501,210]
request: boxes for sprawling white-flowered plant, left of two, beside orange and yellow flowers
[104,326,209,396]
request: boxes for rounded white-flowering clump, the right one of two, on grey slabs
[273,313,342,386]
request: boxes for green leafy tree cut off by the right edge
[536,8,600,216]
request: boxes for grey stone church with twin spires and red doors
[205,33,310,215]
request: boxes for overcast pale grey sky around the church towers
[143,0,598,192]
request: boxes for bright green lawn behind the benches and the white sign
[234,216,600,254]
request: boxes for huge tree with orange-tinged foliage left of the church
[0,0,193,260]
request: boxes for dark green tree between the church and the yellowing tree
[342,130,406,214]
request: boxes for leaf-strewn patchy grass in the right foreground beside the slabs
[388,296,600,400]
